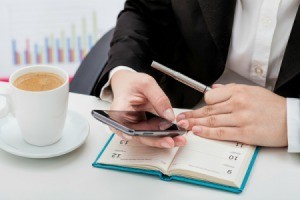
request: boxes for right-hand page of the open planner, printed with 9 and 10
[169,132,255,187]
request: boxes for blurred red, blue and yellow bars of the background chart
[11,11,98,65]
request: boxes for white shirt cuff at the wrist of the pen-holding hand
[286,98,300,153]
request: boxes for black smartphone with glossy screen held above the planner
[92,110,186,137]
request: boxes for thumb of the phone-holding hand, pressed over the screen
[143,79,175,121]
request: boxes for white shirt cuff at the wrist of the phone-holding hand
[99,66,135,103]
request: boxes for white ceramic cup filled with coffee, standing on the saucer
[0,65,69,146]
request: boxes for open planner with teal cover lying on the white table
[93,132,257,193]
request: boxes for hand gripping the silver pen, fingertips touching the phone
[177,84,287,147]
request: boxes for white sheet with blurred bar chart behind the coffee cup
[0,0,125,80]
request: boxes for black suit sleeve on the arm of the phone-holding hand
[94,0,176,96]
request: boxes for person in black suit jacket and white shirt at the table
[95,0,300,152]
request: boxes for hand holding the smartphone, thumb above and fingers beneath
[111,70,186,148]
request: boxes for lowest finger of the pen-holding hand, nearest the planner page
[192,126,242,142]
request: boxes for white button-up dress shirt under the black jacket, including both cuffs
[100,0,300,152]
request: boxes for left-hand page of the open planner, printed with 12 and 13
[97,135,178,174]
